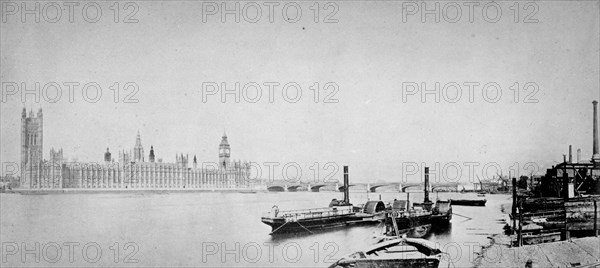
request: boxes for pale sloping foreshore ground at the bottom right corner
[475,234,600,268]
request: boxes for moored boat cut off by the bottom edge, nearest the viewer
[329,238,443,268]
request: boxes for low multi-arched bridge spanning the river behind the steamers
[266,181,459,193]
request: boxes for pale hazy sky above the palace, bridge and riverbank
[0,1,600,184]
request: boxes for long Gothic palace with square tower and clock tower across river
[20,108,250,189]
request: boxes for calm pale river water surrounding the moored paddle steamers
[0,192,511,267]
